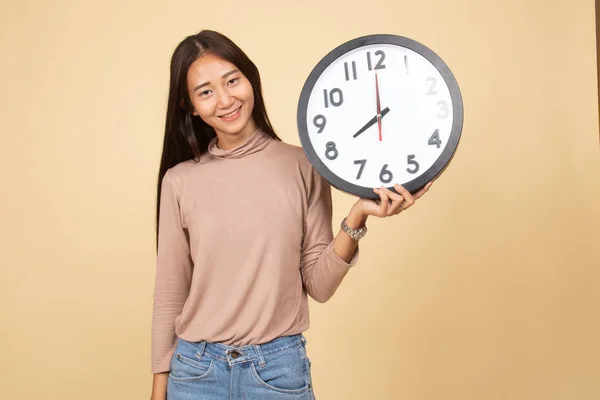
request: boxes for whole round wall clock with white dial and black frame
[298,35,463,198]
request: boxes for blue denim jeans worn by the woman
[167,334,315,400]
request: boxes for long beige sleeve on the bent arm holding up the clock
[300,167,359,303]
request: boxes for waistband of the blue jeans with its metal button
[191,333,306,365]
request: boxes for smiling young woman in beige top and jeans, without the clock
[152,31,431,400]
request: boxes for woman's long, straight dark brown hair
[156,30,281,245]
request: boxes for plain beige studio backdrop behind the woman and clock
[0,0,600,400]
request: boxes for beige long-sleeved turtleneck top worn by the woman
[152,130,359,373]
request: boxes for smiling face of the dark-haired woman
[187,53,256,142]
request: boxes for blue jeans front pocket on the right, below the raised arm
[250,346,311,394]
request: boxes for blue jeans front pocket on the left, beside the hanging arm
[169,342,213,381]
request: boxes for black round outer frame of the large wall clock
[297,34,464,199]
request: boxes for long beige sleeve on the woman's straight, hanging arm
[152,171,193,374]
